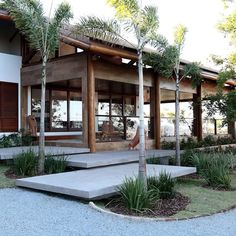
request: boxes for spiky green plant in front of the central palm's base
[118,178,154,212]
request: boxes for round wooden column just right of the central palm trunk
[154,75,161,149]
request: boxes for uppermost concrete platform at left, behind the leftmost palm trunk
[0,146,90,160]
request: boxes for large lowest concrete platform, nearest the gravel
[16,163,196,200]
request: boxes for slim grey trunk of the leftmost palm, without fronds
[38,56,47,174]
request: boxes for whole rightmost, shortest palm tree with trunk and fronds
[145,25,202,166]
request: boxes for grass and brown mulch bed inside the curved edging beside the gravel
[95,175,236,219]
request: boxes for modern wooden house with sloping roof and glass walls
[0,11,236,152]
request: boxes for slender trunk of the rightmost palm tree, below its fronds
[175,77,181,166]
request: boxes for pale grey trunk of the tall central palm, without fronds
[138,50,147,188]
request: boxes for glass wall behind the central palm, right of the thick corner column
[96,87,153,141]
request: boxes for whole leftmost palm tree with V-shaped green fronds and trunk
[4,0,72,174]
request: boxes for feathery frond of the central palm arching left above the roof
[74,16,122,43]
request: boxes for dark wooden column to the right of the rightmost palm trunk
[193,85,202,141]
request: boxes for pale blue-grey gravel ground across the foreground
[0,188,236,236]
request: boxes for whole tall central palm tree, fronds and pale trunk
[75,0,165,186]
